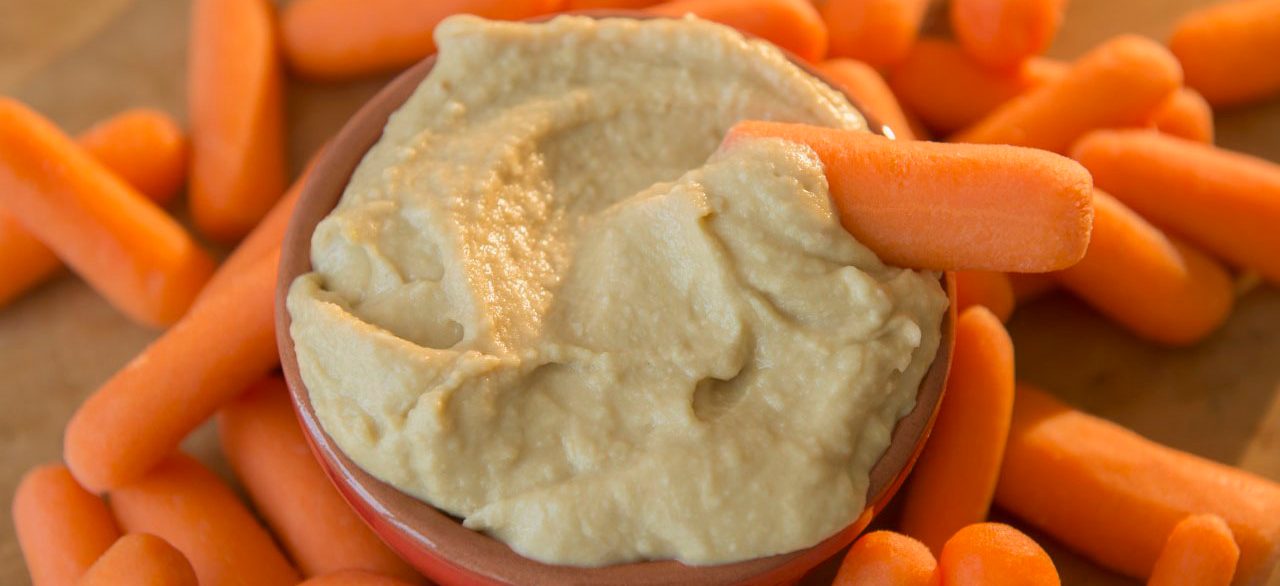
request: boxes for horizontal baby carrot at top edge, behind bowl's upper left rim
[280,0,562,81]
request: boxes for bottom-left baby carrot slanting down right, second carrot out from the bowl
[111,453,298,586]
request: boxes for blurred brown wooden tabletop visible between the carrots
[0,0,1280,585]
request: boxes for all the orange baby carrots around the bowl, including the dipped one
[0,0,1280,586]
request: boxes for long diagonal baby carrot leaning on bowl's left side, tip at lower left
[63,252,279,491]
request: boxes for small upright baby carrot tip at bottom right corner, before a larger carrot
[1147,514,1240,586]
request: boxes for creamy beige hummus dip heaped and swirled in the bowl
[288,17,946,566]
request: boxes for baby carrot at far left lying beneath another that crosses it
[0,110,187,307]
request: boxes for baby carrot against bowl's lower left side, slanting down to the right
[218,376,417,580]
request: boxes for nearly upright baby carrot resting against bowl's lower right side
[900,307,1014,553]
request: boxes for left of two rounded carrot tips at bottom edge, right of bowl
[832,531,938,586]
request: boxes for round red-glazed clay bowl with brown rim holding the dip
[275,12,955,585]
